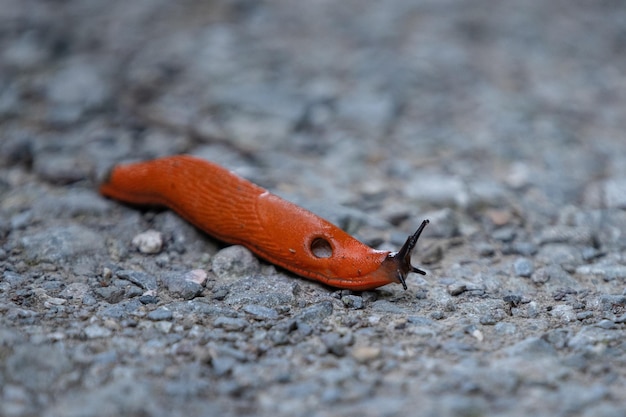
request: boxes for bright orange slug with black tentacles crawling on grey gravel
[100,155,428,290]
